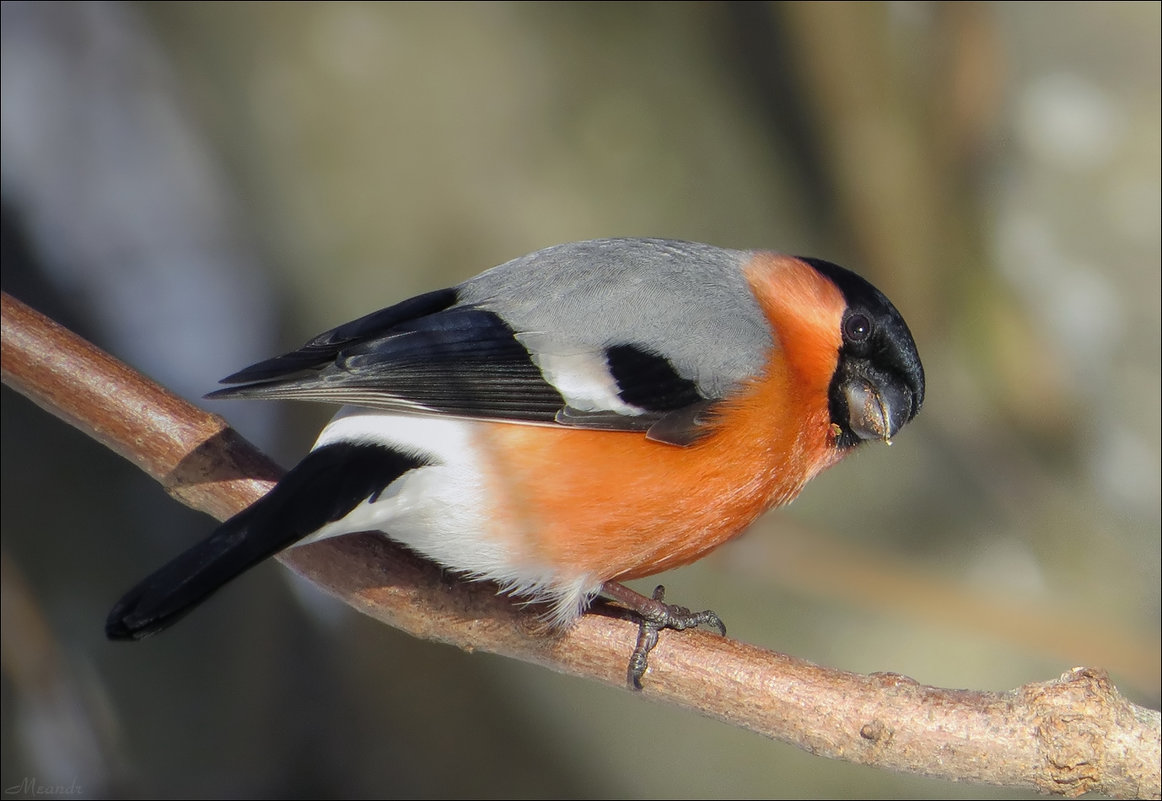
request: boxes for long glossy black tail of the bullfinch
[105,443,426,639]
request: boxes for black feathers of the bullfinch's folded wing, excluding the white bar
[207,284,709,444]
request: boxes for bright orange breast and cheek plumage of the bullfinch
[478,256,842,580]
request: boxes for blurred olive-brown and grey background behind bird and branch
[0,2,1162,798]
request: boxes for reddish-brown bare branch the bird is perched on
[0,293,1162,799]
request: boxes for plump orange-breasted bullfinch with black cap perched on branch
[106,238,925,689]
